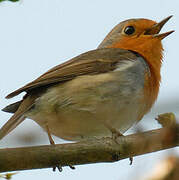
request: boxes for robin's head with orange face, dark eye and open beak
[98,16,174,66]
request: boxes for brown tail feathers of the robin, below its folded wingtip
[0,96,36,139]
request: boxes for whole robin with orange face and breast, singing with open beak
[0,16,173,143]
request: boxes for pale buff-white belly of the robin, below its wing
[26,67,144,140]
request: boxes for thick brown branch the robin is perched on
[0,125,179,172]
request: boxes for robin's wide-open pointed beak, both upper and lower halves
[145,16,174,40]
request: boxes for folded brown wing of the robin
[6,48,137,98]
